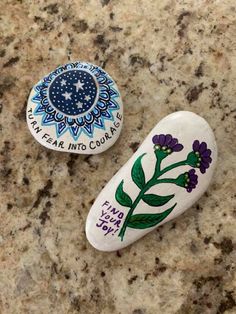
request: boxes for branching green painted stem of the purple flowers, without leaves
[118,156,188,241]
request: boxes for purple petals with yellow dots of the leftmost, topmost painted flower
[152,134,183,154]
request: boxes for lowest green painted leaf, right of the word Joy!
[128,203,177,229]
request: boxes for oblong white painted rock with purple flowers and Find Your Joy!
[86,111,217,251]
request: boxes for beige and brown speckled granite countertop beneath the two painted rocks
[0,0,236,314]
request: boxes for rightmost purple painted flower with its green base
[187,140,212,173]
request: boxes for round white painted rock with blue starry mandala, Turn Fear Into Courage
[26,62,123,154]
